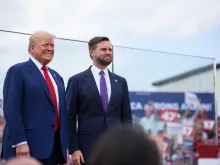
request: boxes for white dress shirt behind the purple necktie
[91,65,111,102]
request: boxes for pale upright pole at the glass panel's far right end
[213,59,218,145]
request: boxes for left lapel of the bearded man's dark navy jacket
[84,67,105,112]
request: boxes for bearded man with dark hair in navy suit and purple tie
[67,37,132,165]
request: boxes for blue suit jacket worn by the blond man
[2,60,68,159]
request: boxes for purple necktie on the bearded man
[99,71,108,111]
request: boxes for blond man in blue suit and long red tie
[2,32,68,165]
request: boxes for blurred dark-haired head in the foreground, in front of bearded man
[88,126,162,165]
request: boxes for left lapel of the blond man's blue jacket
[28,60,53,104]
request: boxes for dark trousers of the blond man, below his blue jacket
[39,129,66,165]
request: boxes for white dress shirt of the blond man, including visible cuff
[12,57,59,147]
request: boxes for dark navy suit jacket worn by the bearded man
[67,68,132,159]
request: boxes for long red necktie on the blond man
[42,65,59,131]
